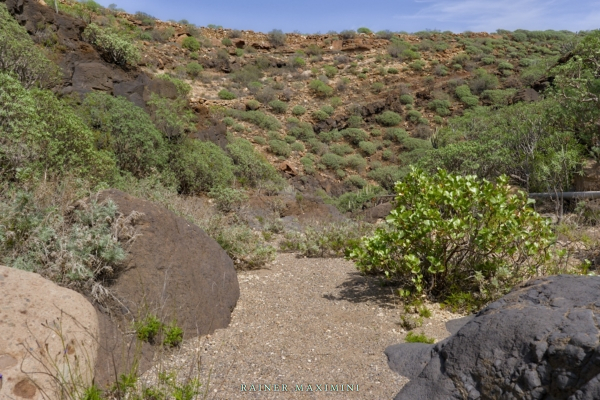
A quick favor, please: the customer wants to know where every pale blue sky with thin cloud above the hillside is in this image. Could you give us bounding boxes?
[96,0,600,33]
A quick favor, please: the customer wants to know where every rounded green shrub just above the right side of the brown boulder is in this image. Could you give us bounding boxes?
[171,139,234,194]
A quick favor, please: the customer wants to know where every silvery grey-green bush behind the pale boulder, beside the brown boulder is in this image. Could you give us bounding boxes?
[0,191,127,288]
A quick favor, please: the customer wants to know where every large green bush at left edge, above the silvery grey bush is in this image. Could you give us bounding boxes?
[0,72,115,181]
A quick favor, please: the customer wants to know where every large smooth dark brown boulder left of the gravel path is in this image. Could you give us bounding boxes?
[89,189,240,384]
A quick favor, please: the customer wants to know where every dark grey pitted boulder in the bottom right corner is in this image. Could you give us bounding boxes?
[388,275,600,400]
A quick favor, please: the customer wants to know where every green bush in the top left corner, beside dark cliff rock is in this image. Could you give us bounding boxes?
[0,4,60,88]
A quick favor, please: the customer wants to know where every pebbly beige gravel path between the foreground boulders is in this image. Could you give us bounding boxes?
[143,254,460,399]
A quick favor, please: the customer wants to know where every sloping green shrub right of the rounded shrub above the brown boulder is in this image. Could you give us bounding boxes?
[227,138,281,187]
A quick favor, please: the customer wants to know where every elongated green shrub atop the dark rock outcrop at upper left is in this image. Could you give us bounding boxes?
[82,23,141,66]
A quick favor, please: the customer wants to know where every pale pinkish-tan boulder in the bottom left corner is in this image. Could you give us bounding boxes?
[0,266,98,400]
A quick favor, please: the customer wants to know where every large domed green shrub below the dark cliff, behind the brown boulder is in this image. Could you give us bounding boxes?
[81,92,168,178]
